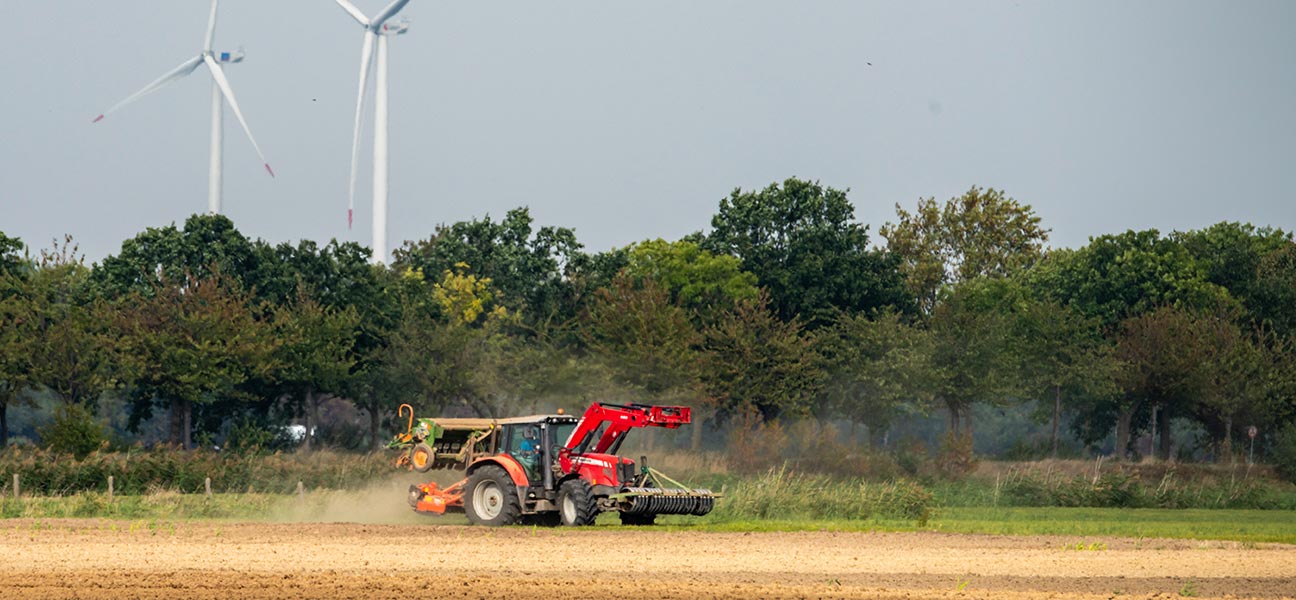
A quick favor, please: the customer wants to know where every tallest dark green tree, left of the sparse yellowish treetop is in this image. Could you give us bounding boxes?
[704,179,910,328]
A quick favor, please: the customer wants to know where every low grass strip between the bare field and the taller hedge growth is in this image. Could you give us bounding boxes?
[0,490,1296,544]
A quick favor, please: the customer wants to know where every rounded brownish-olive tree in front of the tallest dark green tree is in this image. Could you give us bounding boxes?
[702,293,824,420]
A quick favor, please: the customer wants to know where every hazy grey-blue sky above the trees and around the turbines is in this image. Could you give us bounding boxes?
[0,0,1296,260]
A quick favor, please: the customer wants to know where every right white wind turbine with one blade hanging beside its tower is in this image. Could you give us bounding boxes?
[337,0,410,264]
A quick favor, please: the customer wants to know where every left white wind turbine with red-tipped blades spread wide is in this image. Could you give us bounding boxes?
[93,0,275,214]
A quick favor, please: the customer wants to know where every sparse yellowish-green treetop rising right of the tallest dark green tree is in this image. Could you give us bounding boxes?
[881,185,1048,315]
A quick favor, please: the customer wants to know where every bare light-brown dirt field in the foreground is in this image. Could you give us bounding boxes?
[0,520,1296,600]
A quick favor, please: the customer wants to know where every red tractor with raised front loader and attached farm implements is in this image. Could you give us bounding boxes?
[389,403,719,526]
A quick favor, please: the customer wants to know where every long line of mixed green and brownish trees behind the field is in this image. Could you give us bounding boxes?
[0,179,1296,457]
